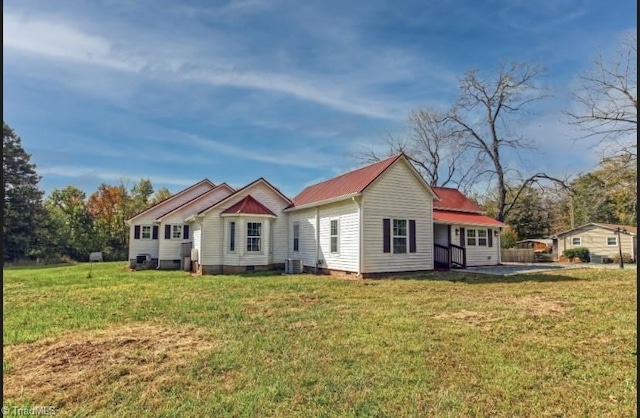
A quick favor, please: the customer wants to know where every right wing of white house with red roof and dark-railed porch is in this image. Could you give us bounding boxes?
[433,187,505,268]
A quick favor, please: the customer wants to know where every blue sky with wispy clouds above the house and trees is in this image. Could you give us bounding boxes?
[3,0,637,196]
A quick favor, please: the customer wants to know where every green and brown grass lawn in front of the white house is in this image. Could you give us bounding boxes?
[2,263,637,417]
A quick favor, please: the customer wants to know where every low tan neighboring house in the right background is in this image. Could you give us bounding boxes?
[552,223,638,260]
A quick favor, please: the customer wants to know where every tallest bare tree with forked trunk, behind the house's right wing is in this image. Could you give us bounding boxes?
[448,63,563,221]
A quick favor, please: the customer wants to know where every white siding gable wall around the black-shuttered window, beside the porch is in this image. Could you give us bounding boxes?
[363,160,433,273]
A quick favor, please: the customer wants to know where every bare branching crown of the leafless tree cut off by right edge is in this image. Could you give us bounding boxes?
[568,33,638,159]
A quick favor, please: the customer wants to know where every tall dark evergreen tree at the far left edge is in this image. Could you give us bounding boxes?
[2,121,44,261]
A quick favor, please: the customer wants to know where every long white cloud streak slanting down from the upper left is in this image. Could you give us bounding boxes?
[3,11,402,119]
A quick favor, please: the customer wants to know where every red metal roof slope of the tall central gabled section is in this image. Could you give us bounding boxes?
[292,154,402,206]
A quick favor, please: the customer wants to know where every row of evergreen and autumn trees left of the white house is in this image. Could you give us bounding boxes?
[2,121,171,262]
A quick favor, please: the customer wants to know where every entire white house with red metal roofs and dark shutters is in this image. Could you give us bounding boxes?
[127,154,504,277]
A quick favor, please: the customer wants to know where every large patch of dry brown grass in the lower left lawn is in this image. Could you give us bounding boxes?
[2,323,218,408]
